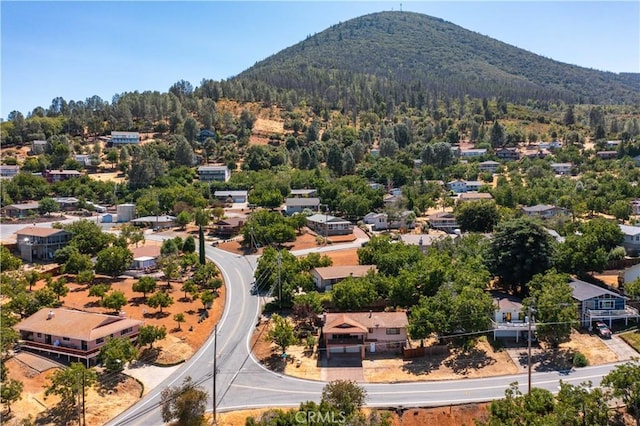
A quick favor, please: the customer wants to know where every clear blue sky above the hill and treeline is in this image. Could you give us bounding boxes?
[0,0,640,118]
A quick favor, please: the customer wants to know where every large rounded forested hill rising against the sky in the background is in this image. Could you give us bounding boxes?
[234,12,640,109]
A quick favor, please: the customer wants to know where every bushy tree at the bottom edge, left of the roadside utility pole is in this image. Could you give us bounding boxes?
[160,376,209,426]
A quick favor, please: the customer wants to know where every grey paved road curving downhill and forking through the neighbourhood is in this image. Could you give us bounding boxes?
[107,240,628,425]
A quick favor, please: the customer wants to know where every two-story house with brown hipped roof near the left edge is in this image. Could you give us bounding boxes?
[16,226,71,262]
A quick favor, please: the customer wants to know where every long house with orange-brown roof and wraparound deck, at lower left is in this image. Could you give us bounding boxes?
[14,308,142,367]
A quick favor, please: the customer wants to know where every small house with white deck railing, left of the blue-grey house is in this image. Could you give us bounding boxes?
[491,292,536,342]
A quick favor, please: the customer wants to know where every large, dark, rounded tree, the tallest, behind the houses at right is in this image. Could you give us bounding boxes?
[486,218,553,295]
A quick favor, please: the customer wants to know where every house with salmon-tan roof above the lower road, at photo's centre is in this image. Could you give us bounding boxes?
[322,311,409,359]
